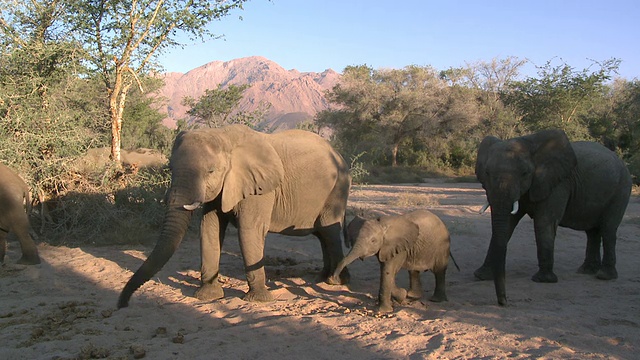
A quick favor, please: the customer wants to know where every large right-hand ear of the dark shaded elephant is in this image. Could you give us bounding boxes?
[522,130,578,202]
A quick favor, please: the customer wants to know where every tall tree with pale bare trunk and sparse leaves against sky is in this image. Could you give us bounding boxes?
[67,0,247,163]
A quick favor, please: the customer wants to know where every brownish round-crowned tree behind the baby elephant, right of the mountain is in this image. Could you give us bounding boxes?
[318,65,449,166]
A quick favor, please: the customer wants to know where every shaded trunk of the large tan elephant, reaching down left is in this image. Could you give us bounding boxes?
[118,208,192,309]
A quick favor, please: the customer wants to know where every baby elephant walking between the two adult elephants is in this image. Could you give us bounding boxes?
[328,210,450,313]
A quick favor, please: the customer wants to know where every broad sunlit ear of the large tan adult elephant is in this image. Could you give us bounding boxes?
[222,138,284,212]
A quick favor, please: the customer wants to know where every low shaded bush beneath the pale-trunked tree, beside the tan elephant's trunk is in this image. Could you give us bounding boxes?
[34,165,170,246]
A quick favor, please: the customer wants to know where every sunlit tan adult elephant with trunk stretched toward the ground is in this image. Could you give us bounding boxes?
[118,125,351,308]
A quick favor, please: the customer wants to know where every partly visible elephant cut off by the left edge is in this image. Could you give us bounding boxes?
[0,164,40,265]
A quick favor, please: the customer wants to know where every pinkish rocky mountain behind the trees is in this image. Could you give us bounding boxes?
[159,56,340,129]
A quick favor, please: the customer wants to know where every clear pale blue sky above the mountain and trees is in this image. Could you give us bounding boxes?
[160,0,640,80]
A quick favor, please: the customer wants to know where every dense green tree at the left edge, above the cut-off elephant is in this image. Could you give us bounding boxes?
[0,1,101,193]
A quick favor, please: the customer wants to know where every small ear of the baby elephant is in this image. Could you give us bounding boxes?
[378,216,420,262]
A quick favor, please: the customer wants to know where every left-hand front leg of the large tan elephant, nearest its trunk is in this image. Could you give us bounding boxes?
[194,207,228,301]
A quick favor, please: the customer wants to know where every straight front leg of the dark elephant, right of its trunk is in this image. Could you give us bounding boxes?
[531,220,558,283]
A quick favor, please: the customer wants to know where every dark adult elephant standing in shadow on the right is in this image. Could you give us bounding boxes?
[475,130,632,305]
